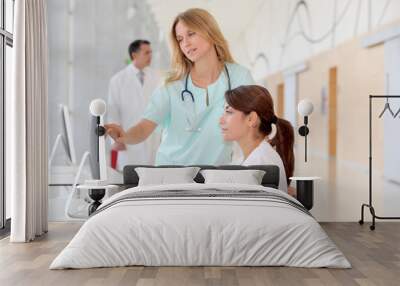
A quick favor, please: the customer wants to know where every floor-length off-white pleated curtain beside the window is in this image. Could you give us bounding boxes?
[6,0,48,242]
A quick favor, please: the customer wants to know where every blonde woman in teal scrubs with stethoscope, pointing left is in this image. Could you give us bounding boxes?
[106,9,254,165]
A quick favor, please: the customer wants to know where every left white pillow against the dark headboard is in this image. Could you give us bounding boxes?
[135,167,200,186]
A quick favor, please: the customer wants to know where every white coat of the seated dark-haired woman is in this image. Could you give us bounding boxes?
[234,140,288,193]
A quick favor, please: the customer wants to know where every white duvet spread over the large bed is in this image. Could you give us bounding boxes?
[50,184,351,269]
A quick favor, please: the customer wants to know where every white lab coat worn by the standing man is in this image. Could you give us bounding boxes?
[107,64,161,170]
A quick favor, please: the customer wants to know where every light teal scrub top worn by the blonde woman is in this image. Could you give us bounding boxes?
[143,63,254,165]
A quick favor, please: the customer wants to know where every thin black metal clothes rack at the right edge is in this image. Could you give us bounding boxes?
[358,95,400,230]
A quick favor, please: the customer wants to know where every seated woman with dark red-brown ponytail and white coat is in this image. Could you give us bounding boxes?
[220,85,294,192]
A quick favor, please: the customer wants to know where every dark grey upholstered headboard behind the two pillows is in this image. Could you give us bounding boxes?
[124,165,279,189]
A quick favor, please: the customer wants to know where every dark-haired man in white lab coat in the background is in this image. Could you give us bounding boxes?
[107,40,161,170]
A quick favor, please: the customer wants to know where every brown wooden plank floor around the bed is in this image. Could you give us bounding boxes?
[0,222,400,286]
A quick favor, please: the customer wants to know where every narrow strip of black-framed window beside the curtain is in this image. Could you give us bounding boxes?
[0,0,14,233]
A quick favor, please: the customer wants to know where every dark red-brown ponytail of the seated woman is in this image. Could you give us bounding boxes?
[270,118,294,184]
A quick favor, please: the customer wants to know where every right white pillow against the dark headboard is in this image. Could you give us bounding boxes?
[200,170,265,185]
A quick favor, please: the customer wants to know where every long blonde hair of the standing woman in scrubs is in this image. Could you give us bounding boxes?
[165,8,234,83]
